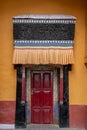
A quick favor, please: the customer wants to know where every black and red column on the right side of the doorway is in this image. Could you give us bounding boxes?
[59,65,69,127]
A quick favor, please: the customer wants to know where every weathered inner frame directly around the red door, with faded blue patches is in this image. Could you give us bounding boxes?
[26,65,59,124]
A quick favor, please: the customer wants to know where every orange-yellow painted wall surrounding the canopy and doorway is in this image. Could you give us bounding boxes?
[0,0,87,104]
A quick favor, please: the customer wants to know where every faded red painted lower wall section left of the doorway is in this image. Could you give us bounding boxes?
[0,101,16,124]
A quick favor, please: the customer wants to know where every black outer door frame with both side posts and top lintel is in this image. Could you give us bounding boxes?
[14,65,71,128]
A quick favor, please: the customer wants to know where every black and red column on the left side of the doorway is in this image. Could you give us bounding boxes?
[15,65,26,128]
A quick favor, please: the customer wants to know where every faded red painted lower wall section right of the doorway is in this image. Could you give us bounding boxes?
[69,105,86,128]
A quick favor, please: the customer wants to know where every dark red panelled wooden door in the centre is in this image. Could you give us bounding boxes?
[31,71,53,124]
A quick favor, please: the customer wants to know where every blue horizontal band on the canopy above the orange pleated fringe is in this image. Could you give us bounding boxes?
[14,42,74,47]
